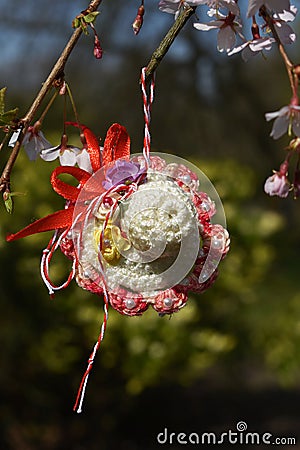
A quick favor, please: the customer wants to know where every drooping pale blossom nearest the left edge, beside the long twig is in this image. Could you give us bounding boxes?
[8,123,51,161]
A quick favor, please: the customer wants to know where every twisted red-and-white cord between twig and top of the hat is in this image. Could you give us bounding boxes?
[141,67,155,168]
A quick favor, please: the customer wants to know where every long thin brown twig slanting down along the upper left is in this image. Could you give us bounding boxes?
[0,0,102,192]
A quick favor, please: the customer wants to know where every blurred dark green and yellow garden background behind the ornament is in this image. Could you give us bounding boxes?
[0,0,300,450]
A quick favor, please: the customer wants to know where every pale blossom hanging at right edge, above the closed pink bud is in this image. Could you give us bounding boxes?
[265,103,300,139]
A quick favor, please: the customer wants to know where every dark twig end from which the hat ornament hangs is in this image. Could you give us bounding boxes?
[145,5,196,82]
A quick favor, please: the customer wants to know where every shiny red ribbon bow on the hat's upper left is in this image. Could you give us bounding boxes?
[6,122,130,242]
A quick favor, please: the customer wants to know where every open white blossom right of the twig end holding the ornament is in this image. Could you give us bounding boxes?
[194,10,243,52]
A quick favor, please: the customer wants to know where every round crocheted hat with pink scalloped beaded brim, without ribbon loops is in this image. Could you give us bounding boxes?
[70,149,229,316]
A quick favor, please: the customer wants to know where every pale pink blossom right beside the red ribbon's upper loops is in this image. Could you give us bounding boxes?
[40,134,92,173]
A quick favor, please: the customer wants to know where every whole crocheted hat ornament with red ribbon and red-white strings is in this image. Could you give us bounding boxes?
[7,67,229,412]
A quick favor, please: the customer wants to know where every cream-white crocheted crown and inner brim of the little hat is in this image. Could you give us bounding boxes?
[80,172,200,297]
